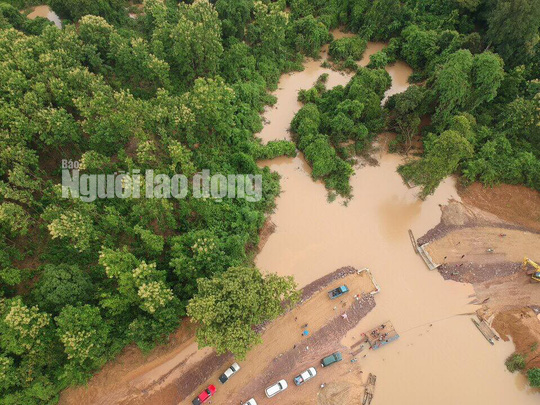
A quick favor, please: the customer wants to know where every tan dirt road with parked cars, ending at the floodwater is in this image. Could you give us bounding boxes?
[162,272,376,405]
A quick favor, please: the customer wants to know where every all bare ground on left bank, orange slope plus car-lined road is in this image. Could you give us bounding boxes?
[60,267,377,405]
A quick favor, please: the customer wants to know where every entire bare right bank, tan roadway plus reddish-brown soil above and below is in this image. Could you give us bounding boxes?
[418,184,540,368]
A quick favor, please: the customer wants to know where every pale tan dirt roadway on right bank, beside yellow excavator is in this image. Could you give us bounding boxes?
[418,198,540,311]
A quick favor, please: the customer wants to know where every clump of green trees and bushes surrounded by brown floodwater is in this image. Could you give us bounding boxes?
[291,68,391,197]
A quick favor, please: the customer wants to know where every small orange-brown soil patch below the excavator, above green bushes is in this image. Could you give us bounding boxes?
[493,307,540,369]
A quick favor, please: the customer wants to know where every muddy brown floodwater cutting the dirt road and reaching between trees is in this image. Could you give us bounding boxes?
[256,39,540,405]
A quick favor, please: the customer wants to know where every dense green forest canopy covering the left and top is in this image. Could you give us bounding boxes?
[0,0,540,404]
